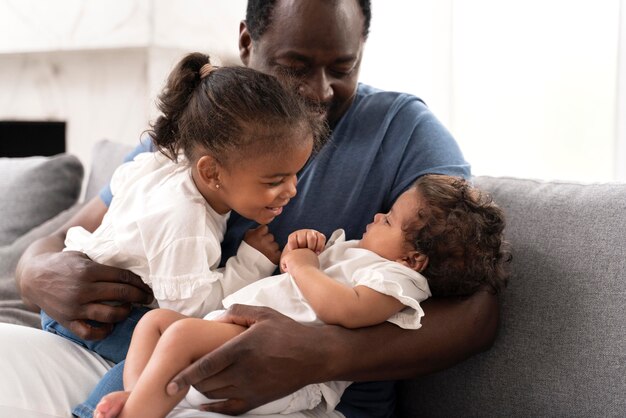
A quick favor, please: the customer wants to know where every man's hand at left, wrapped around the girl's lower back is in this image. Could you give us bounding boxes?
[21,251,153,340]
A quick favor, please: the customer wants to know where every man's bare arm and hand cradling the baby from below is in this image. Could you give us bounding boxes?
[167,291,498,414]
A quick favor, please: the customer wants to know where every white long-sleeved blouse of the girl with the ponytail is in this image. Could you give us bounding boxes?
[65,152,276,317]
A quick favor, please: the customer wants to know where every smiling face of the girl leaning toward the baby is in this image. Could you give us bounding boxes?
[219,139,313,225]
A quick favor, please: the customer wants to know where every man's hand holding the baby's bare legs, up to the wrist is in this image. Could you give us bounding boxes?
[168,305,332,415]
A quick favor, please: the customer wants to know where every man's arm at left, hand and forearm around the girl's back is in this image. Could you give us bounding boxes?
[15,197,152,339]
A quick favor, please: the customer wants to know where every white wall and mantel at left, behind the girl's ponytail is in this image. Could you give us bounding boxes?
[0,0,246,178]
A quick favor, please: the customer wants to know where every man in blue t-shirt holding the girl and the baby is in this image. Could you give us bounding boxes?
[6,0,498,417]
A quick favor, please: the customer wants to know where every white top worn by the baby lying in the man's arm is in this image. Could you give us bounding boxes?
[223,229,430,329]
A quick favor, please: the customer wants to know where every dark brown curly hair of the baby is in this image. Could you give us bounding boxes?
[405,174,512,296]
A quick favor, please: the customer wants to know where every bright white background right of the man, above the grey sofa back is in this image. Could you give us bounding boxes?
[362,0,626,181]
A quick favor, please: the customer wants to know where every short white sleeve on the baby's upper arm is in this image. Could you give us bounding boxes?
[354,262,430,329]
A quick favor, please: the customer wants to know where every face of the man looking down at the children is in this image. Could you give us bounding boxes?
[239,0,365,128]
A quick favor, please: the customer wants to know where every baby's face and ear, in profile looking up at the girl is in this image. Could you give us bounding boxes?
[359,187,421,262]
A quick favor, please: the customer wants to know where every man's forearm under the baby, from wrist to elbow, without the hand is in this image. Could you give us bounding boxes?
[316,291,498,381]
